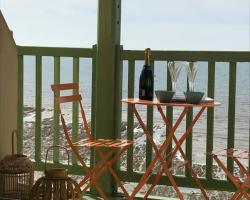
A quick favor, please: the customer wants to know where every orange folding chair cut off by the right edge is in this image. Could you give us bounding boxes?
[212,148,250,200]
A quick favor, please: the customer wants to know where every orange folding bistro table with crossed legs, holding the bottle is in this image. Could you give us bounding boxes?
[121,98,221,200]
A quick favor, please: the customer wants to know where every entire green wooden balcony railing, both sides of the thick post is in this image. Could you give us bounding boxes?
[18,46,250,195]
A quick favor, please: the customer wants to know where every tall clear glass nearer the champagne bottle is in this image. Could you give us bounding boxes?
[168,61,181,97]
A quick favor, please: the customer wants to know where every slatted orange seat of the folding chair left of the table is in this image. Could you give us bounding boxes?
[66,139,133,148]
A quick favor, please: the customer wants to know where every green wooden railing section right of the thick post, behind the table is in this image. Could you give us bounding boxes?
[120,50,250,191]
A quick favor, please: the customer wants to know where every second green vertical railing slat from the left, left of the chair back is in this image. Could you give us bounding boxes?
[35,56,42,161]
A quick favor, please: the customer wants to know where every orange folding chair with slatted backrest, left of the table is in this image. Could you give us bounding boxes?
[51,83,132,199]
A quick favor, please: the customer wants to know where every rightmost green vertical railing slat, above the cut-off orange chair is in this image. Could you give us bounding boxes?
[227,62,237,172]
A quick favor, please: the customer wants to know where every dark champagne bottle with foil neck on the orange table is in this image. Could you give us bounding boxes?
[139,48,154,100]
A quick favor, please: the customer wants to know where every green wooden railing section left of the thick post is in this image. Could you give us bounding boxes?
[18,46,95,174]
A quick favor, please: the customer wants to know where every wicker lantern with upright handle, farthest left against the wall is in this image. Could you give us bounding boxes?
[0,130,34,200]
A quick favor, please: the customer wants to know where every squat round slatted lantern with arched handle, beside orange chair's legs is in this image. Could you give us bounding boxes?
[30,146,83,200]
